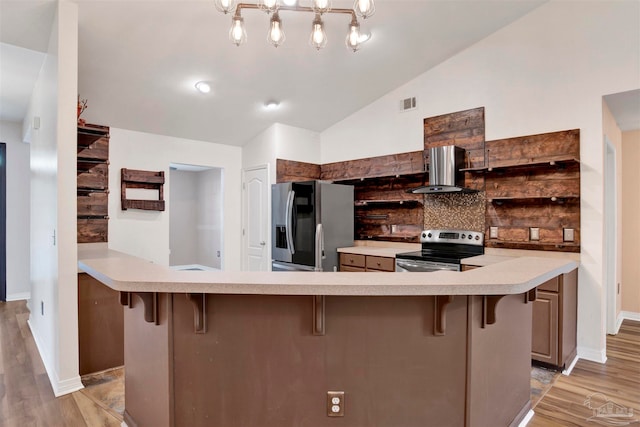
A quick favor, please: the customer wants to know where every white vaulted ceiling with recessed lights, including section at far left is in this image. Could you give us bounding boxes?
[0,0,636,145]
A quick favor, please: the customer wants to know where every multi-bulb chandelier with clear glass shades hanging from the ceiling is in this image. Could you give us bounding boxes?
[214,0,376,52]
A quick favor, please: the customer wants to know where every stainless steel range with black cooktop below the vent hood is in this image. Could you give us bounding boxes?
[396,230,484,272]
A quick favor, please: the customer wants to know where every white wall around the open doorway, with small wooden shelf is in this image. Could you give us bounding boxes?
[109,128,242,270]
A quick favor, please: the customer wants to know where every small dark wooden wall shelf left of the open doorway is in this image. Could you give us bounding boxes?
[120,168,164,211]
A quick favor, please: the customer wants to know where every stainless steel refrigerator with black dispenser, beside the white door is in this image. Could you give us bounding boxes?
[271,181,353,271]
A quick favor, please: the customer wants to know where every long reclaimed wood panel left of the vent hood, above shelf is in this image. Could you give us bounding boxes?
[321,151,425,181]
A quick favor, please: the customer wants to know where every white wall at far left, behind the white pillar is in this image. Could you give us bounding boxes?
[0,121,31,301]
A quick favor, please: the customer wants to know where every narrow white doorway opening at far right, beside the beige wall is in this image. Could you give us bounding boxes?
[604,136,618,335]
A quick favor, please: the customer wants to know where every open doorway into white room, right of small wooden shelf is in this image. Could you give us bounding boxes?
[169,163,224,271]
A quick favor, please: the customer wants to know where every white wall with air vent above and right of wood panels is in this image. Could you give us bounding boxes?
[321,1,640,361]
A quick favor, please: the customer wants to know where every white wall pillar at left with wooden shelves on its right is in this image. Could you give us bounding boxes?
[25,1,82,396]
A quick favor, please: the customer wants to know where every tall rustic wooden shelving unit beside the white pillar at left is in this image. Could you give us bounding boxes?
[76,124,109,243]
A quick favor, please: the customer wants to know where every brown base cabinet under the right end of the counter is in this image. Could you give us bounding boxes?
[531,270,578,369]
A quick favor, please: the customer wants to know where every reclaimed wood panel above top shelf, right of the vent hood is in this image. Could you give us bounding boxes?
[486,129,580,168]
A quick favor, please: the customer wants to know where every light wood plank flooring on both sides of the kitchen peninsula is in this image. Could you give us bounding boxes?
[0,301,640,427]
